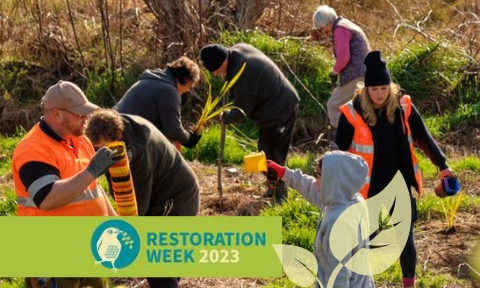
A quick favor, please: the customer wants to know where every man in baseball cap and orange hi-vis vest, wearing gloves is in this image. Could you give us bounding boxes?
[12,81,116,288]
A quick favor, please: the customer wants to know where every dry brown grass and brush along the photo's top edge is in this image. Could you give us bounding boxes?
[0,0,480,72]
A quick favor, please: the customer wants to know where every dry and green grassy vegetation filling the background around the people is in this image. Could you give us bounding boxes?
[0,0,480,288]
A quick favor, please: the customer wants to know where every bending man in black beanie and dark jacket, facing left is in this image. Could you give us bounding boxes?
[200,43,300,202]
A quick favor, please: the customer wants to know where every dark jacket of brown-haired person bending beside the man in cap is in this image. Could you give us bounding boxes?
[110,114,200,216]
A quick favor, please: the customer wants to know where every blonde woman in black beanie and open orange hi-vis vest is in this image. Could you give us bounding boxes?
[335,51,455,287]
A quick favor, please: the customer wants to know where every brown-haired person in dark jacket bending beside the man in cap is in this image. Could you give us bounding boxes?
[86,109,200,288]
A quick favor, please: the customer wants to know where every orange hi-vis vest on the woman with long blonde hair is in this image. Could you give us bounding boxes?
[340,95,422,199]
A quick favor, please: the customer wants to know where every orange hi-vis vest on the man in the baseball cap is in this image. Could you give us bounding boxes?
[12,124,108,216]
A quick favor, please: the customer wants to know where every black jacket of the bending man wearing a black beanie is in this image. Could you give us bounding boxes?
[224,43,300,128]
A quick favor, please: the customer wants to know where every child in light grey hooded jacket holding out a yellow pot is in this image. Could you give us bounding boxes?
[268,151,375,288]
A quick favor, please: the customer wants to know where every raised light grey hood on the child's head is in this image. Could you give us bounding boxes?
[321,151,368,207]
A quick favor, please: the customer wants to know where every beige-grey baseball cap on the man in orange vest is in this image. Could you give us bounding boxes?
[42,80,100,116]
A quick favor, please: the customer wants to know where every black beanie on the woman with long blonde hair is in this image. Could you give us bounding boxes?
[364,50,391,87]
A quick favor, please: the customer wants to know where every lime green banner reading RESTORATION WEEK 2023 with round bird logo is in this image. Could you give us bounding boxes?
[0,217,282,277]
